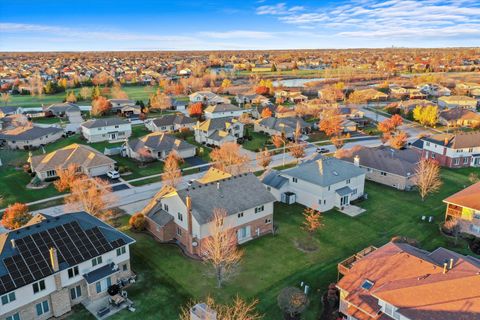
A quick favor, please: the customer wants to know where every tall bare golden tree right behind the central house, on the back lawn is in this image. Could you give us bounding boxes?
[202,208,243,288]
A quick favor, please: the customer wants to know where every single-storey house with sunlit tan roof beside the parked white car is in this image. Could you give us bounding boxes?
[28,143,116,181]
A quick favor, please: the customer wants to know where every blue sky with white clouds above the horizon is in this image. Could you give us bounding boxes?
[0,0,480,51]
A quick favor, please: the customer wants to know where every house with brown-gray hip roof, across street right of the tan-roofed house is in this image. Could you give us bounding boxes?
[125,132,196,162]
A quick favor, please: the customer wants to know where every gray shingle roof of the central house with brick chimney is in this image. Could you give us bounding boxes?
[177,173,275,224]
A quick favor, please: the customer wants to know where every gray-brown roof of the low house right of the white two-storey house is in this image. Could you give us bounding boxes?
[342,146,421,177]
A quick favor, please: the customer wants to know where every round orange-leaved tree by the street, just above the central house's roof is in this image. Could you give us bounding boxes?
[210,141,250,174]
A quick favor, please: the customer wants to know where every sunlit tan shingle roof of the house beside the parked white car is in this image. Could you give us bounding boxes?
[31,143,116,172]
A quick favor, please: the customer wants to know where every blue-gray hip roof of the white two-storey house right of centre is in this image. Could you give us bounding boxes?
[282,156,365,187]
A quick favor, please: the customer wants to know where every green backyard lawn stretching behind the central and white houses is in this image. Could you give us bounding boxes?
[68,169,474,320]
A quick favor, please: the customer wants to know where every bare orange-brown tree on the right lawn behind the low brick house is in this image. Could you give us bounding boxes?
[415,159,442,201]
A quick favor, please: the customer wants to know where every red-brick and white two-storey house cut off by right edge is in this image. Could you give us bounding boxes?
[422,131,480,168]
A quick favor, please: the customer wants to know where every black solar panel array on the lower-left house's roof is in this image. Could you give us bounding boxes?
[0,221,125,295]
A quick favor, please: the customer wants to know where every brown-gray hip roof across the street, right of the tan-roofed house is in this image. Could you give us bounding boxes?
[128,132,196,152]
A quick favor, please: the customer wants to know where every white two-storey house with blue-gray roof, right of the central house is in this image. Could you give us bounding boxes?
[262,156,365,212]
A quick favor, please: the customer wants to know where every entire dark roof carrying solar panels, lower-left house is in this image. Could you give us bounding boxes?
[0,212,135,295]
